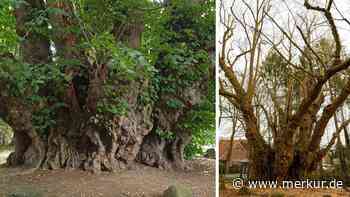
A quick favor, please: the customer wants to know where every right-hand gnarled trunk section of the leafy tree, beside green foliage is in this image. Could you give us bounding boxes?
[138,82,208,169]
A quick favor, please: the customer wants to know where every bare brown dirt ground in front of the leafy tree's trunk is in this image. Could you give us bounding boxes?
[0,159,215,197]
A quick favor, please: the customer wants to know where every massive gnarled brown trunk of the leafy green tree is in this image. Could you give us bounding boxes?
[0,0,211,172]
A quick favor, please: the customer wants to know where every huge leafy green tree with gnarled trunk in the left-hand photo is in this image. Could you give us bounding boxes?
[0,0,214,172]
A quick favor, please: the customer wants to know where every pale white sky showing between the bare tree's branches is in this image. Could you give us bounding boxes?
[217,0,350,144]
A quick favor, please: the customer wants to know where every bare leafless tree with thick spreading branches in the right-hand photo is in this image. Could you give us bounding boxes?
[219,0,350,180]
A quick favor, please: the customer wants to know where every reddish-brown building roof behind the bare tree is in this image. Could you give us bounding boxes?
[219,139,248,162]
